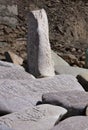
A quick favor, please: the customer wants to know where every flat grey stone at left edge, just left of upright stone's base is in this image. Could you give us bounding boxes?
[0,66,35,80]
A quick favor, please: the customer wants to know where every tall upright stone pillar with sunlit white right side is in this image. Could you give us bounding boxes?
[27,9,55,77]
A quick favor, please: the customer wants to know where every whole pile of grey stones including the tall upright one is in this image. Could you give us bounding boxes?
[0,9,88,130]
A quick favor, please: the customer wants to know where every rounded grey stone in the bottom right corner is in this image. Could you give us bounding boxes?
[51,116,88,130]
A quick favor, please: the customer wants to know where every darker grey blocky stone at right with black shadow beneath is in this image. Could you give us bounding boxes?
[42,91,88,116]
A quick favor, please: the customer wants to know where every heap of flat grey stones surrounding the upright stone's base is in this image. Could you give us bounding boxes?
[0,53,88,130]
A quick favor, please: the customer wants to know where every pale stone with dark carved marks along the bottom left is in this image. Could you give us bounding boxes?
[0,104,67,130]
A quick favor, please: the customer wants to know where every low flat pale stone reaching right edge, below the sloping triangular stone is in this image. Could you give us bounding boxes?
[55,66,88,77]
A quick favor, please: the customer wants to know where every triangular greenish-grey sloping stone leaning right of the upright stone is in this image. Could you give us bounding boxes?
[51,50,69,70]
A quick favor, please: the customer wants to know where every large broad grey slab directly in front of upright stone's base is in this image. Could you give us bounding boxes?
[0,75,84,113]
